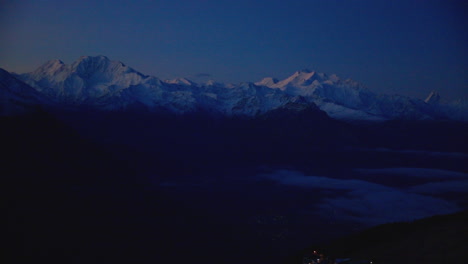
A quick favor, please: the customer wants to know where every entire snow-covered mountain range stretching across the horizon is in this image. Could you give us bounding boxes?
[0,56,468,121]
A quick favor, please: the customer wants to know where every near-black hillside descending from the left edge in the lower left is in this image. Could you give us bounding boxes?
[0,114,239,263]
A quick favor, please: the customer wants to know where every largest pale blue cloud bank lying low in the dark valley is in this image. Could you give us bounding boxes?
[261,169,462,225]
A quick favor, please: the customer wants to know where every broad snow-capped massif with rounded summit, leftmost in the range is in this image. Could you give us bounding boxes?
[18,56,156,104]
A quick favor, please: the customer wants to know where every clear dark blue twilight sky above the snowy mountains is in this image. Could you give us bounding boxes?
[0,0,468,99]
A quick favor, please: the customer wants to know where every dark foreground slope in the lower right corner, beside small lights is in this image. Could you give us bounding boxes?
[288,211,468,264]
